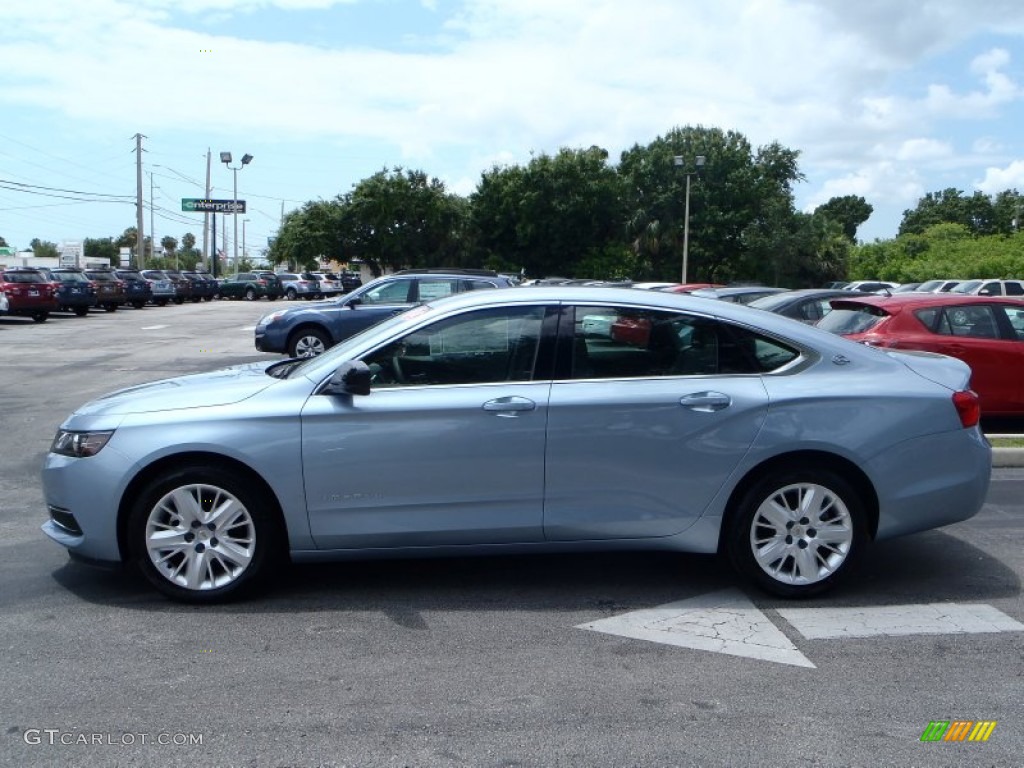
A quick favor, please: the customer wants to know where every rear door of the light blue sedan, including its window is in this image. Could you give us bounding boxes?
[544,306,770,541]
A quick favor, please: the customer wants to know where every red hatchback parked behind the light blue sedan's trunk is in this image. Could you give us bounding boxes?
[817,293,1024,416]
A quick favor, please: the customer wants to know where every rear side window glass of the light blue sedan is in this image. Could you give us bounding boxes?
[570,306,800,379]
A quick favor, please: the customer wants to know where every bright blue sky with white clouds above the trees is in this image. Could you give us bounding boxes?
[0,0,1024,262]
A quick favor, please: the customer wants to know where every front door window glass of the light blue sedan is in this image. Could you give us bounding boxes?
[364,307,545,387]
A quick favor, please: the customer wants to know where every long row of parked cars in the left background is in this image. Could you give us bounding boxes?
[0,267,361,323]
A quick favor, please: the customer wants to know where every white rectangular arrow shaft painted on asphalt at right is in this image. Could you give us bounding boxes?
[778,603,1024,640]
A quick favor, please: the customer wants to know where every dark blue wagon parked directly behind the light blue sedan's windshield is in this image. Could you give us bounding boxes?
[256,269,512,357]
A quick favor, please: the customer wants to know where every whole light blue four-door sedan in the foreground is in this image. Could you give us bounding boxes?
[43,287,991,602]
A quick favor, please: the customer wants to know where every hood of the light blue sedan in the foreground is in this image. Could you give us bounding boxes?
[69,361,275,416]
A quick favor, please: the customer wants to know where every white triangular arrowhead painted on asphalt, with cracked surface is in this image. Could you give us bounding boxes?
[577,590,814,669]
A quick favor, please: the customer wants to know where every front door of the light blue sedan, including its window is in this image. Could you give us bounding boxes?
[302,306,553,549]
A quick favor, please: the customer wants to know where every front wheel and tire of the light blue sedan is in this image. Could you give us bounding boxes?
[127,464,287,603]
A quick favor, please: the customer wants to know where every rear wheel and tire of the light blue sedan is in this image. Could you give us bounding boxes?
[727,466,867,598]
